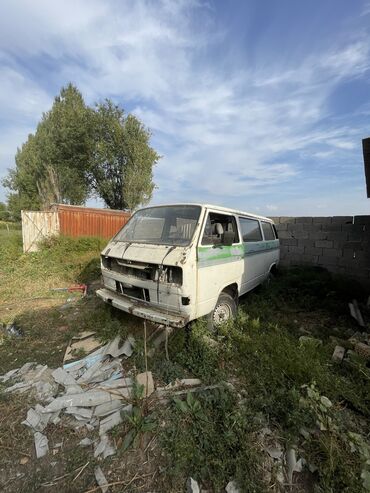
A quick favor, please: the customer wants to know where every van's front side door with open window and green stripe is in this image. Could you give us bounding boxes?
[197,211,244,317]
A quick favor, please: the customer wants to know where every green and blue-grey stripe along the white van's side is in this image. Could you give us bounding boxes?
[198,240,279,267]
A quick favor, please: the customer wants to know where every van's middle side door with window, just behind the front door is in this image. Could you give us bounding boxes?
[239,216,266,294]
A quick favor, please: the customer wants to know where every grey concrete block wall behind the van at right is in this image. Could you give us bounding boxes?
[271,216,370,285]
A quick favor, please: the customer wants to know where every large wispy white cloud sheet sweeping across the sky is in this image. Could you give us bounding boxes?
[0,0,370,212]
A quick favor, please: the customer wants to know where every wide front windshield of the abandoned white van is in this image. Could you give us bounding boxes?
[114,205,201,246]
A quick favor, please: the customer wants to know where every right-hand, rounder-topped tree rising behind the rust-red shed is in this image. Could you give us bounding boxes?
[89,99,160,210]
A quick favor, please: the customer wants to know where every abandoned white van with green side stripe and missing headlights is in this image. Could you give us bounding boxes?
[97,204,279,327]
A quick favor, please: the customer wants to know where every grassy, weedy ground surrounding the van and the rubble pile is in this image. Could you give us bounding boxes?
[0,232,370,493]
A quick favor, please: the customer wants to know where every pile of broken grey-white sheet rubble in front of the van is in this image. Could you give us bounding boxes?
[0,336,135,460]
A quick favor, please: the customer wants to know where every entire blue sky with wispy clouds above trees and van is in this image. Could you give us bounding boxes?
[0,0,370,216]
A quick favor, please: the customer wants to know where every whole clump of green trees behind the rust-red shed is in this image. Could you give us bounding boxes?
[3,84,159,218]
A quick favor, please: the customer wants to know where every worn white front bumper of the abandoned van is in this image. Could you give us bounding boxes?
[96,288,189,327]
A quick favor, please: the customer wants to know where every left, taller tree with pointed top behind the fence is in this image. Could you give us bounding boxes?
[4,84,93,217]
